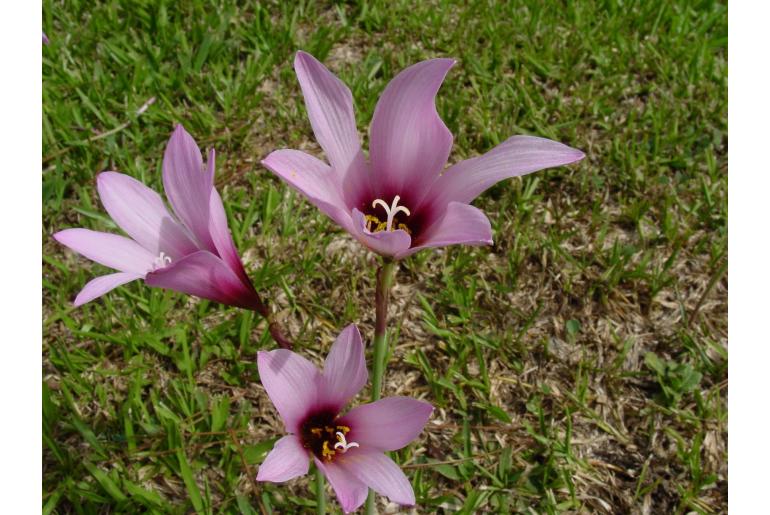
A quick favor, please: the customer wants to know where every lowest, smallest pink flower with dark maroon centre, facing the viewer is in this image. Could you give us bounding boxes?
[257,325,433,513]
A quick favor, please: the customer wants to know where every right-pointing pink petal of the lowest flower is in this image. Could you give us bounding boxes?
[341,397,433,451]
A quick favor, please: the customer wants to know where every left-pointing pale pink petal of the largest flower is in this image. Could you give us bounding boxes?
[262,149,352,231]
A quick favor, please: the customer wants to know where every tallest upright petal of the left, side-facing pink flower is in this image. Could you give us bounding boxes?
[163,125,215,252]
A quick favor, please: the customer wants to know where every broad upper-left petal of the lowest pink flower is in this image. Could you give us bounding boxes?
[257,349,321,433]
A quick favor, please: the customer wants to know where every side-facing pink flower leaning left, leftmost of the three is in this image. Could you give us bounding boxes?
[54,125,266,311]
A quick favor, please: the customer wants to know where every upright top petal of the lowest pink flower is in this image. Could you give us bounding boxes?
[321,324,369,411]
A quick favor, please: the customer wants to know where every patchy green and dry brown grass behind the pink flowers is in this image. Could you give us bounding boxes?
[42,0,727,513]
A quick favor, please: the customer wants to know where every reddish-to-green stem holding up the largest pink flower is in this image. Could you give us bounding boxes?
[366,260,396,515]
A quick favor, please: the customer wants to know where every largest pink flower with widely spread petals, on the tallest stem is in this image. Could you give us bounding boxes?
[262,52,584,259]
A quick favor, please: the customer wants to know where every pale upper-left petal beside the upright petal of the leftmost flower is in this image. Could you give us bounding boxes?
[96,172,198,259]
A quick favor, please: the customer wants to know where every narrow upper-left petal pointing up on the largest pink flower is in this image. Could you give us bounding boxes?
[294,52,361,177]
